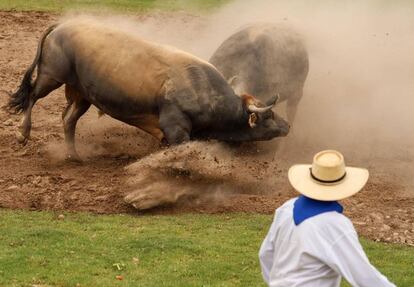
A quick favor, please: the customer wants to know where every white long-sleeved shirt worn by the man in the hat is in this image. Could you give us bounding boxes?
[259,198,395,287]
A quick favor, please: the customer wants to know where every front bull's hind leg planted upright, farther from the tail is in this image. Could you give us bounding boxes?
[62,85,91,161]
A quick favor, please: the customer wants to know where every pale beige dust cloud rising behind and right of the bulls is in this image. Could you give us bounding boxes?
[137,0,414,160]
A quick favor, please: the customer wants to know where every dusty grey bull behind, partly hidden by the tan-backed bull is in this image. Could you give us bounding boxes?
[210,23,309,124]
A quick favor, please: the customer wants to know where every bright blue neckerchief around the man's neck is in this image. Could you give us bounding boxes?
[293,195,344,225]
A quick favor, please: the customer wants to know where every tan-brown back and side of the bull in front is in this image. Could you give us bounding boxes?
[48,19,212,122]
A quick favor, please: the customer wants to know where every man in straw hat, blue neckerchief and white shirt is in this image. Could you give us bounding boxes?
[259,150,395,287]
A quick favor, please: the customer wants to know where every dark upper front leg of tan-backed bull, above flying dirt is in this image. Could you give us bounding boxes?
[160,104,192,145]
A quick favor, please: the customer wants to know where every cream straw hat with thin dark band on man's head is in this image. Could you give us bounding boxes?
[288,150,369,201]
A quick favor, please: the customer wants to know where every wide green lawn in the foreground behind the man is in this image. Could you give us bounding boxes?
[0,210,414,287]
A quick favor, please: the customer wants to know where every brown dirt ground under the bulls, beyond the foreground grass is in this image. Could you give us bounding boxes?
[0,11,414,245]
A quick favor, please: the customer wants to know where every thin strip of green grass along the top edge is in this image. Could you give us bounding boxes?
[0,0,230,12]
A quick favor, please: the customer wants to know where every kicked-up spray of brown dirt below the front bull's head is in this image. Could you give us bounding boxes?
[125,142,276,209]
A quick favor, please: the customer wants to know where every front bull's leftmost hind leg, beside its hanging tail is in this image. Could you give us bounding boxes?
[17,74,62,144]
